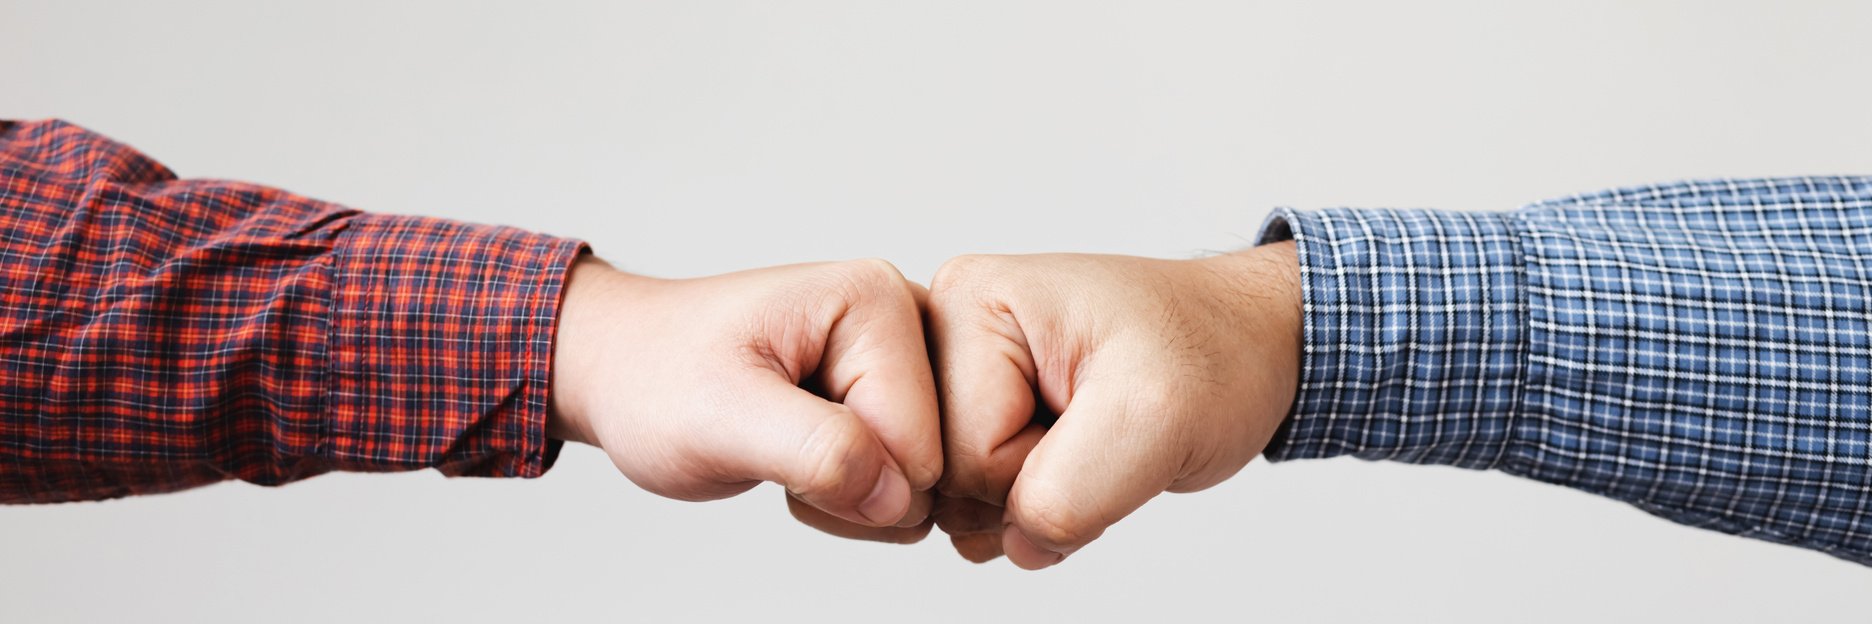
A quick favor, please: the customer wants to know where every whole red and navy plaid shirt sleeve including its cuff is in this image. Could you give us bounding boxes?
[0,122,584,502]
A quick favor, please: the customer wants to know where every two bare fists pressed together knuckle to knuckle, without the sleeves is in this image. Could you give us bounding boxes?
[548,242,1301,570]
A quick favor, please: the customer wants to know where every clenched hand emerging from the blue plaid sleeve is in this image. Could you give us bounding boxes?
[929,242,1301,570]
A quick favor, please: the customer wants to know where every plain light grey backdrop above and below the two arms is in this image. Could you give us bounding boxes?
[0,0,1872,622]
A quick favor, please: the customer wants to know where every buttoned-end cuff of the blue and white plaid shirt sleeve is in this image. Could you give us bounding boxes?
[1260,208,1528,468]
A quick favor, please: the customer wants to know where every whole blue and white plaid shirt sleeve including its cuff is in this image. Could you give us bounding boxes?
[1262,176,1872,564]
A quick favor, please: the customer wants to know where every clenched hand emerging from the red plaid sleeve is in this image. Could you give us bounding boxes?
[547,259,942,542]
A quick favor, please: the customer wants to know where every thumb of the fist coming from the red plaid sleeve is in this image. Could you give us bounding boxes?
[717,379,910,527]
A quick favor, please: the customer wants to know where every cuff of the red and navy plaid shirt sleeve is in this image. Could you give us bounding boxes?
[320,214,586,476]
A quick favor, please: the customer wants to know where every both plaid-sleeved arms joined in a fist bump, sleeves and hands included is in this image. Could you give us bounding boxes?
[0,120,1872,568]
